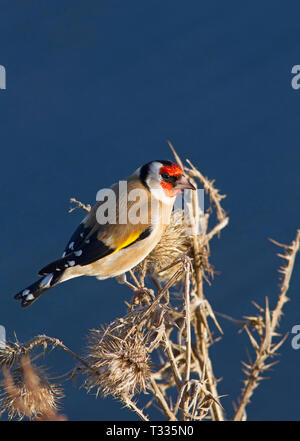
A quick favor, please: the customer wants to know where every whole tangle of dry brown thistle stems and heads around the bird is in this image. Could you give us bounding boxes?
[0,143,300,421]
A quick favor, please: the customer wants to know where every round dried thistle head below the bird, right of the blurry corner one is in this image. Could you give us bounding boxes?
[86,321,150,400]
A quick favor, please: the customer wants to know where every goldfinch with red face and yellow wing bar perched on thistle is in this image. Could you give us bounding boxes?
[15,160,194,307]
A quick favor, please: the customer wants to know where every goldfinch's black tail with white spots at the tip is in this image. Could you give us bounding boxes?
[15,272,63,308]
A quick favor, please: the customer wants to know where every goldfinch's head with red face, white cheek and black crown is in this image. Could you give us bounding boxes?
[137,160,195,203]
